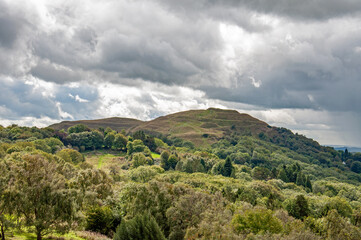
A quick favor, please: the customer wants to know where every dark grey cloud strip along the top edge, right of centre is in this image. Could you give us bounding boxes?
[160,0,361,23]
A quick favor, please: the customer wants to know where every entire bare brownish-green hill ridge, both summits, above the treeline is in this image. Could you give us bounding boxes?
[49,108,275,146]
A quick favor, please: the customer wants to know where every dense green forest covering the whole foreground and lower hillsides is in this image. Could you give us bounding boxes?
[0,110,361,240]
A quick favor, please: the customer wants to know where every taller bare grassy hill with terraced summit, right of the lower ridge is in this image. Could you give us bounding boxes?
[130,108,273,146]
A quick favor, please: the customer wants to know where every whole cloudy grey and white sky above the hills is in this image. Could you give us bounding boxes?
[0,0,361,147]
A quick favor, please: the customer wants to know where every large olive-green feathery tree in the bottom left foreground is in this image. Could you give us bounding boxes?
[13,155,75,240]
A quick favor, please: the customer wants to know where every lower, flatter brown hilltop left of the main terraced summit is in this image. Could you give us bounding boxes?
[49,117,143,131]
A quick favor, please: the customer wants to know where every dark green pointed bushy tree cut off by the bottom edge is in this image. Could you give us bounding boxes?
[114,213,166,240]
